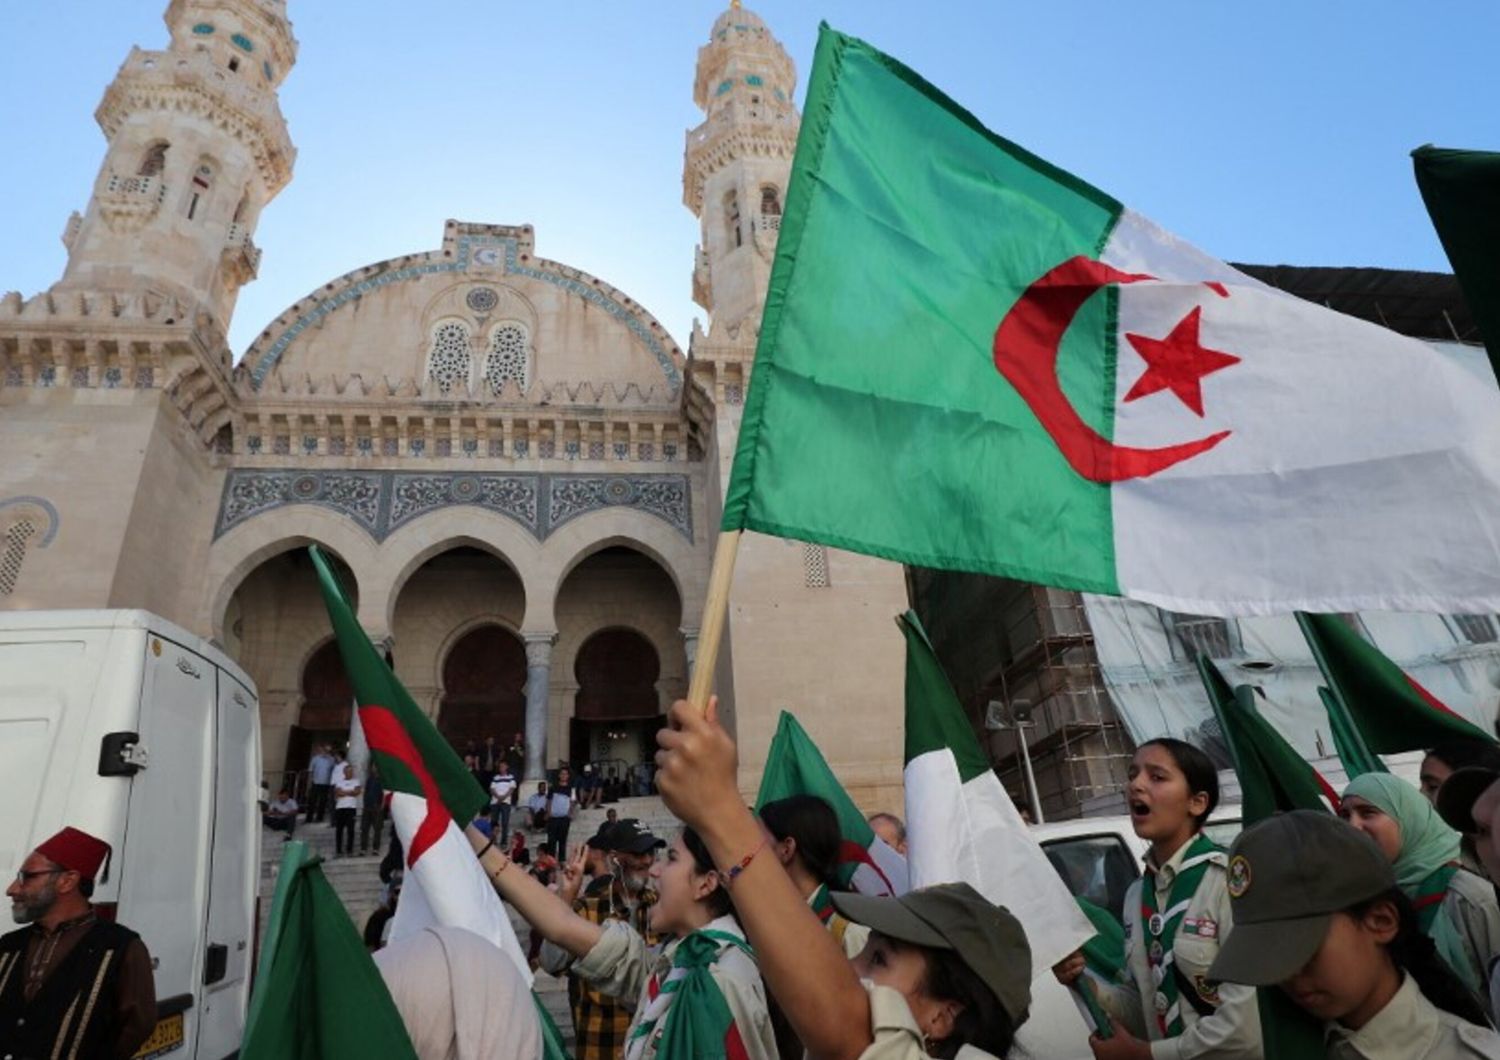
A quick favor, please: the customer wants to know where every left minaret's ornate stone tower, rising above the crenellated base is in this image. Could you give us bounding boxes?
[53,0,297,331]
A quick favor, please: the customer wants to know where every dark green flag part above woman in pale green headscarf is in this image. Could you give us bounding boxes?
[1298,612,1493,754]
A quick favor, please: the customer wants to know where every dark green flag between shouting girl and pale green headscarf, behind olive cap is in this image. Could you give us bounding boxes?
[1197,654,1337,1060]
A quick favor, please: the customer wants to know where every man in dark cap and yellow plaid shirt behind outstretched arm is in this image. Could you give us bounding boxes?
[542,817,666,1060]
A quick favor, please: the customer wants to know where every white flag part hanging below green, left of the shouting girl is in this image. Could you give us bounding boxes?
[906,748,1094,1060]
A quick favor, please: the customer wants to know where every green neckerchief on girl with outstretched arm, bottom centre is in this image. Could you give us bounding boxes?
[626,928,755,1060]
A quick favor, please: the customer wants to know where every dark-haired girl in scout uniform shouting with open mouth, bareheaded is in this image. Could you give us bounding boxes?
[1055,739,1262,1060]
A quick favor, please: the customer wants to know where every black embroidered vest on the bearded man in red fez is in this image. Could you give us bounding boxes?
[0,921,138,1060]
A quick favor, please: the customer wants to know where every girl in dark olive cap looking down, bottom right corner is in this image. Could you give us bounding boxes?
[1209,810,1500,1060]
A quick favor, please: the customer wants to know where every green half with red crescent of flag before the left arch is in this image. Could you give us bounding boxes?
[308,544,489,845]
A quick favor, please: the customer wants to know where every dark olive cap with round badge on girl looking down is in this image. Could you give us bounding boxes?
[1208,810,1397,987]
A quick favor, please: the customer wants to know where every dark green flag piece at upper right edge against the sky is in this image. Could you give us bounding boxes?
[1412,144,1500,375]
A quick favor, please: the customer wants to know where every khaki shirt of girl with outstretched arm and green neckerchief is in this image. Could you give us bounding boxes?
[573,916,779,1060]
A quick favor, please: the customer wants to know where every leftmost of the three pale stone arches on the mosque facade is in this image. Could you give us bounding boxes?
[200,505,375,643]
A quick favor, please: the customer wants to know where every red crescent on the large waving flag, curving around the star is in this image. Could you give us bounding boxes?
[995,255,1230,483]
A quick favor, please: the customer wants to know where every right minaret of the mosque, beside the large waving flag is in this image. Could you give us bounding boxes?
[683,0,798,345]
